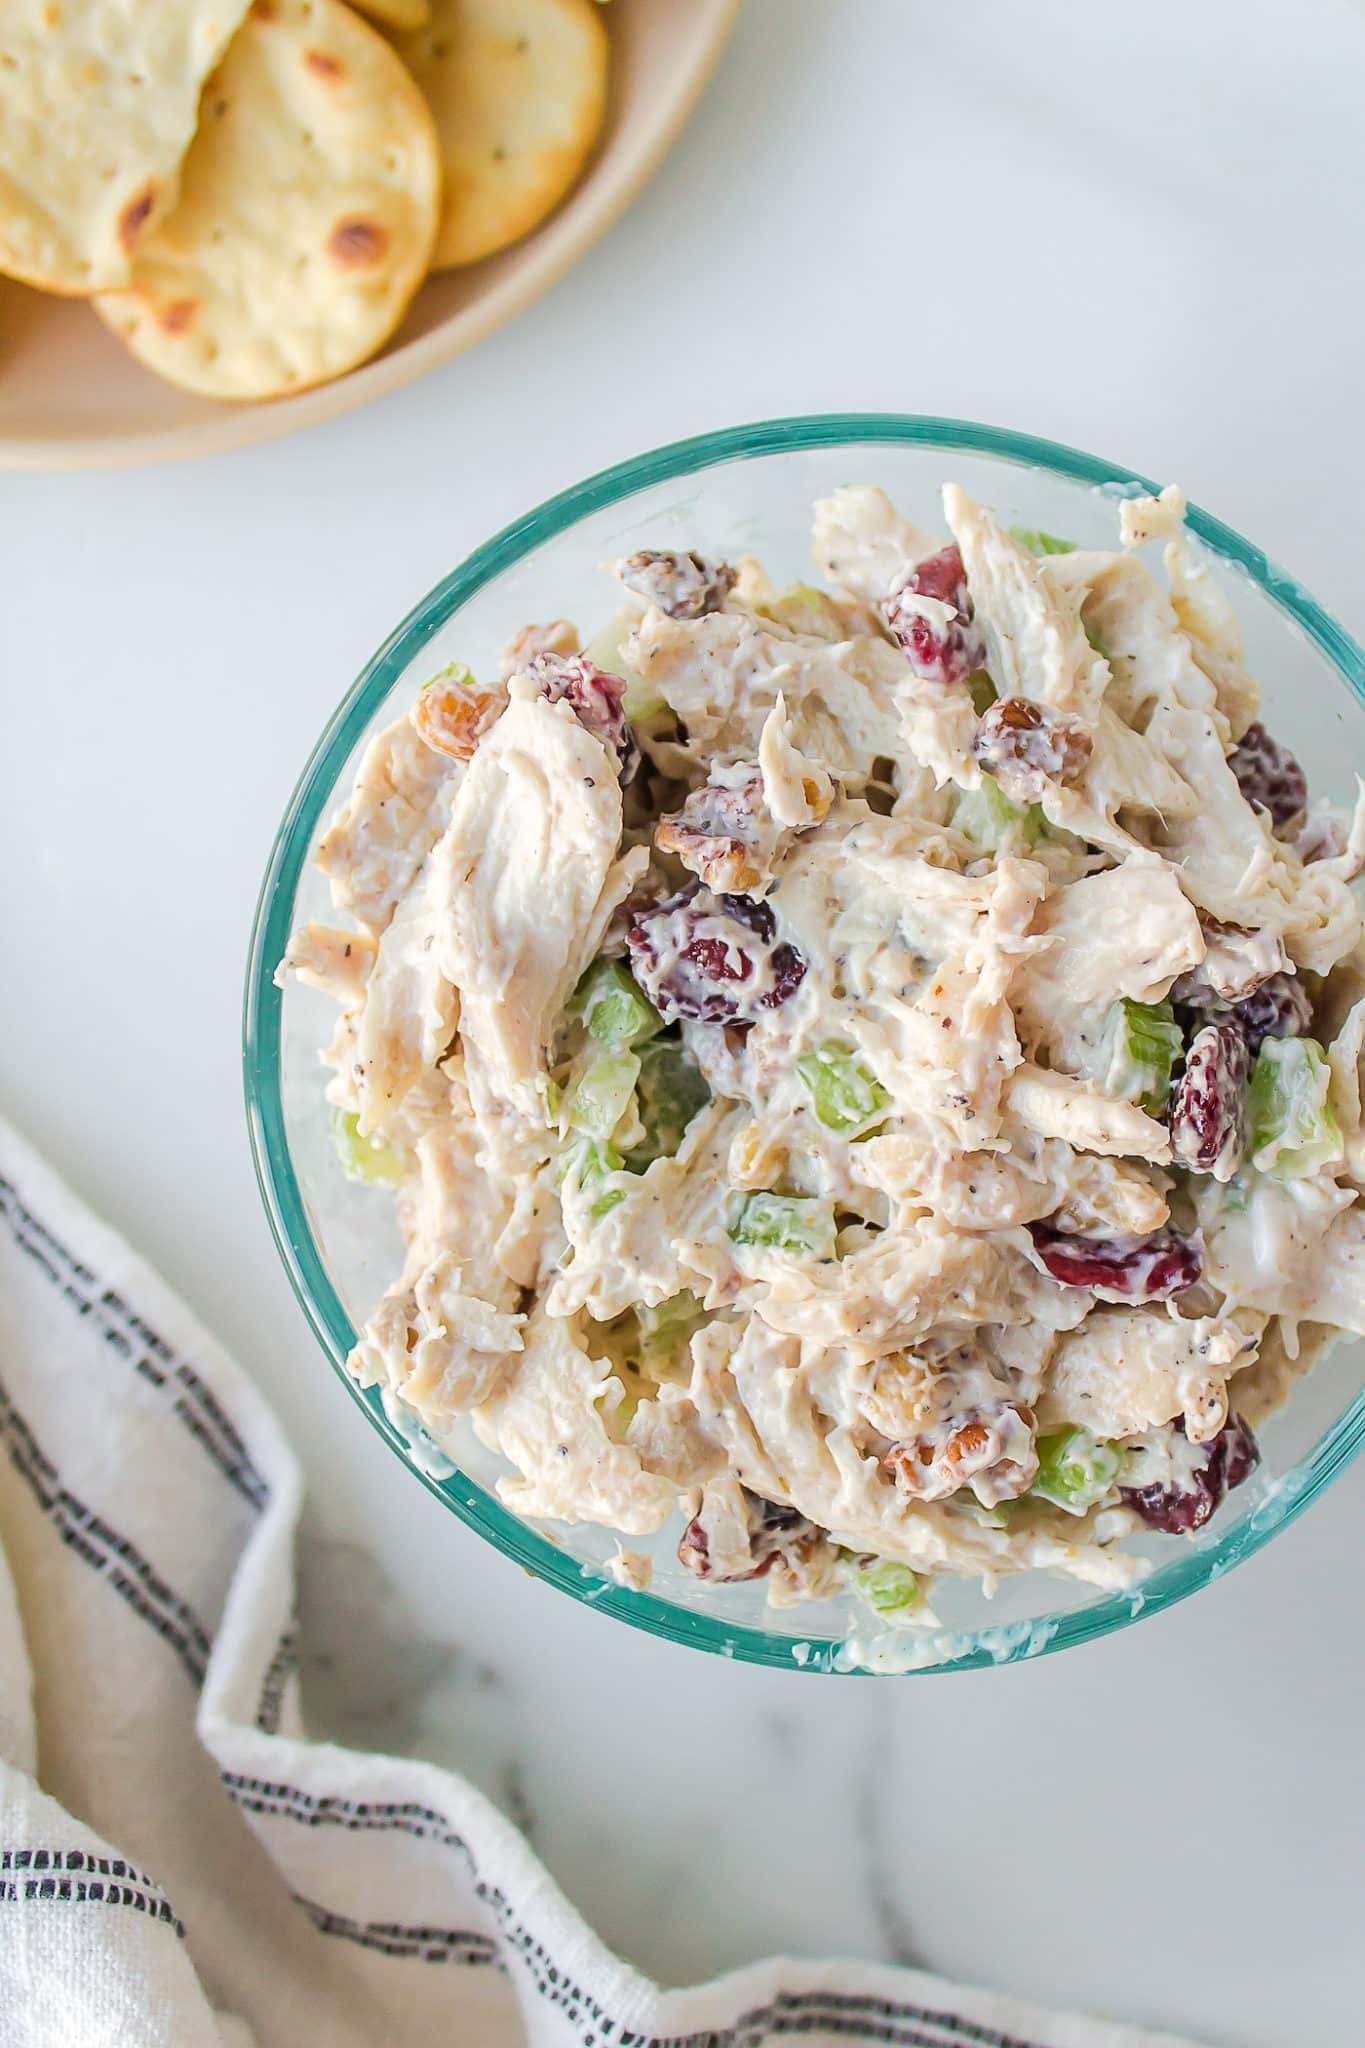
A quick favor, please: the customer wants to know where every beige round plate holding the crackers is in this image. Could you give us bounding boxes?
[0,0,739,469]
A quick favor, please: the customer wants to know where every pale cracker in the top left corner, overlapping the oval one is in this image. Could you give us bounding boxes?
[0,0,248,295]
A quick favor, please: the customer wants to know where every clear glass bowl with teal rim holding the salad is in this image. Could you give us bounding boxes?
[244,414,1365,1671]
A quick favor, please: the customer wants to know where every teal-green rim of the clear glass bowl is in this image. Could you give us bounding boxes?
[241,412,1365,1675]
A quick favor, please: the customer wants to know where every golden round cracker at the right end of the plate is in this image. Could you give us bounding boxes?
[395,0,608,270]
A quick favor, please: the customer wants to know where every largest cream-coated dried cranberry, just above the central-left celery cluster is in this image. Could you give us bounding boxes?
[626,883,806,1024]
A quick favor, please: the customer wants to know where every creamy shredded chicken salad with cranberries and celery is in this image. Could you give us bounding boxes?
[282,485,1365,1630]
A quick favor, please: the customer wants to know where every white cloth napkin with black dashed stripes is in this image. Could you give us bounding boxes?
[0,1124,1189,2048]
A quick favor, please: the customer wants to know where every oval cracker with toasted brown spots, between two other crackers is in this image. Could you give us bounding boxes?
[94,0,440,399]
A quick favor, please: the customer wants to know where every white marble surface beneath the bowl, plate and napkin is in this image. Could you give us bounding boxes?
[0,0,1365,2048]
